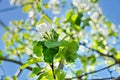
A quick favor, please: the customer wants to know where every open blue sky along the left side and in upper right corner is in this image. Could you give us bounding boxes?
[0,0,120,80]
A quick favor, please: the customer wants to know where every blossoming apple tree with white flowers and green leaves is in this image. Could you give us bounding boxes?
[0,0,120,80]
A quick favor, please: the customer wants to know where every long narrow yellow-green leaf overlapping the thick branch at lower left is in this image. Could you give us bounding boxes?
[20,58,42,69]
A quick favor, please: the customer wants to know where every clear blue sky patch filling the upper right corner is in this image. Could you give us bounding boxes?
[99,0,120,25]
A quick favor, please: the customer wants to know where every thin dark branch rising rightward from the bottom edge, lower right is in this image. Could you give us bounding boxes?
[66,62,118,80]
